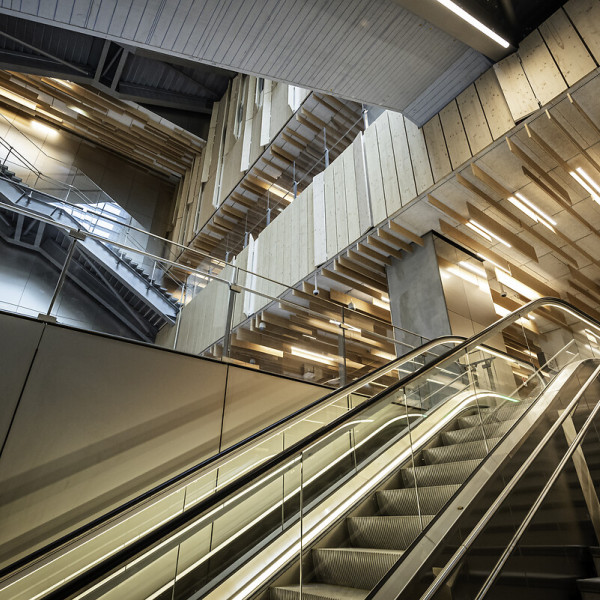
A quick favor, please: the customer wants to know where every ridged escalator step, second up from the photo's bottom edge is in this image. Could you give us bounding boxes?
[312,548,403,590]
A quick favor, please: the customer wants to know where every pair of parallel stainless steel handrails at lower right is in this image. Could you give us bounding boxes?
[420,366,600,600]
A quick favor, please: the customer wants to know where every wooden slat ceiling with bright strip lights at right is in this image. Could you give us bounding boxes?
[392,74,600,328]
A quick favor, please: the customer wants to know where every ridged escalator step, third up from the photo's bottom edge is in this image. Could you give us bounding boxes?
[346,515,435,550]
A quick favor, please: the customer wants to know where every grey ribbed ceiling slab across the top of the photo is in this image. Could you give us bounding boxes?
[0,0,490,120]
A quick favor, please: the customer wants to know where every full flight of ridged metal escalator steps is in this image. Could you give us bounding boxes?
[270,402,529,600]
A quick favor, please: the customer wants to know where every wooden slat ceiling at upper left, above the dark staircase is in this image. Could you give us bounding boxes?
[0,71,205,179]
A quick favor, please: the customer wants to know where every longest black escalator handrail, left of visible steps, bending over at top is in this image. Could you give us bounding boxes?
[7,297,600,600]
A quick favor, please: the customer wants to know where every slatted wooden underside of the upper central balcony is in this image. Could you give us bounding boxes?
[171,93,363,278]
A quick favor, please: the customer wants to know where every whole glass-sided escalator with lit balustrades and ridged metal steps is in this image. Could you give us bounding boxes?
[0,299,600,600]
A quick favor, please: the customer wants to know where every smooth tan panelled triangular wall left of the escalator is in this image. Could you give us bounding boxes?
[0,313,328,564]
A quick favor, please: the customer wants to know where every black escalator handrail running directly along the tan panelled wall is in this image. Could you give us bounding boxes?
[0,335,466,580]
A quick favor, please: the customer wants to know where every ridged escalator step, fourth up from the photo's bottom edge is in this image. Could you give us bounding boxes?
[376,484,460,516]
